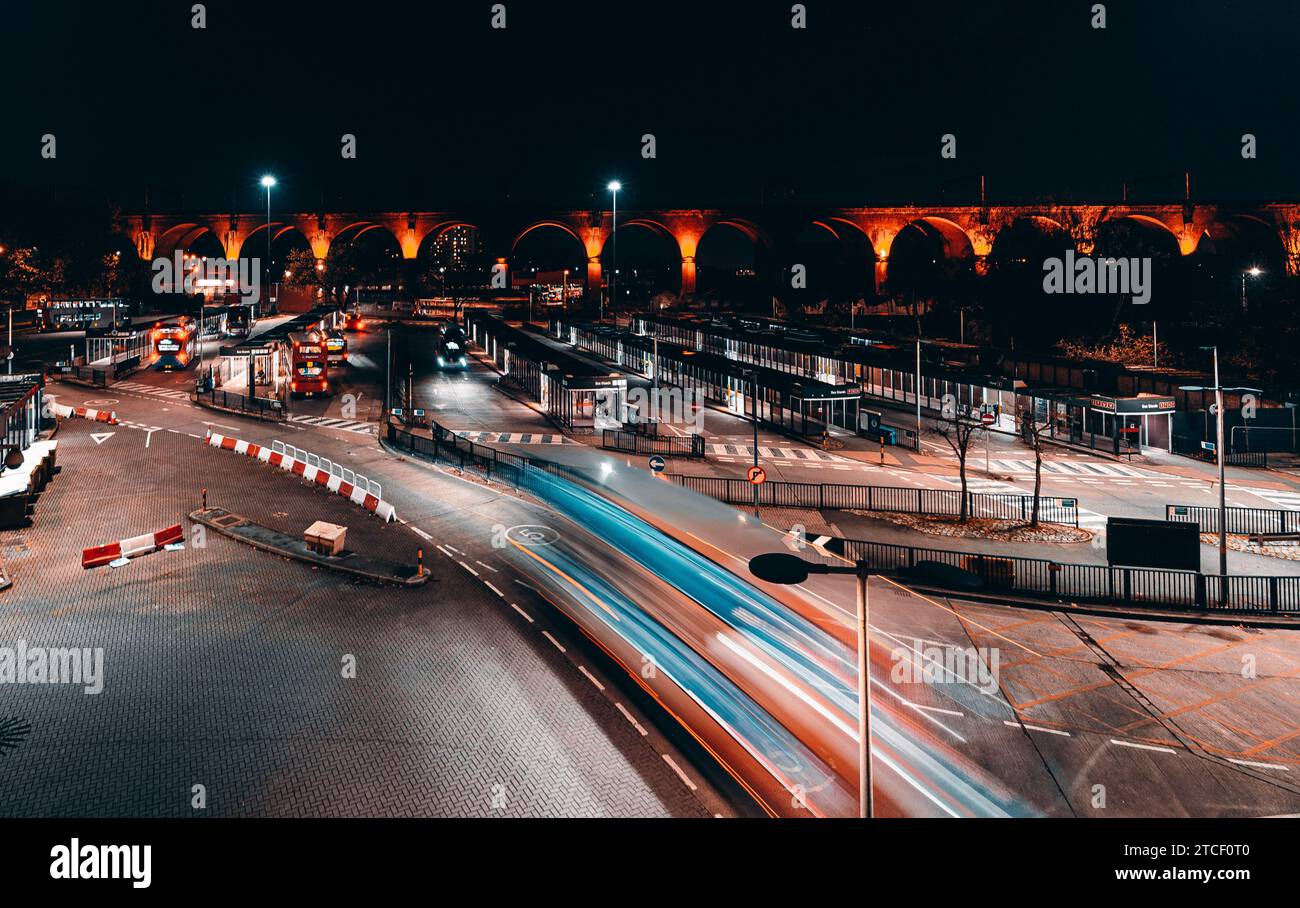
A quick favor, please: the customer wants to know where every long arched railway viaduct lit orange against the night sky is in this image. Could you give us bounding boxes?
[117,202,1300,294]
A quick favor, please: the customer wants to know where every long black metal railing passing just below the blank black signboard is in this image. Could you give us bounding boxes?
[803,540,1300,614]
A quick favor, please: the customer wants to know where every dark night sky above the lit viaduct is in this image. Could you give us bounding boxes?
[0,0,1300,209]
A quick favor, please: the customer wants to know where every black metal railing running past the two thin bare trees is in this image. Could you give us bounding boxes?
[670,474,1079,527]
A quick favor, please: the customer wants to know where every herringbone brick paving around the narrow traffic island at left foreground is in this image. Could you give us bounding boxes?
[0,423,706,817]
